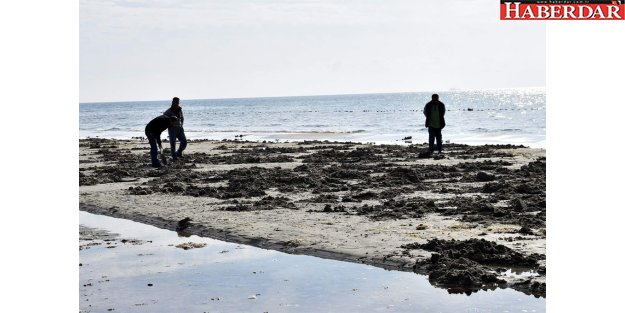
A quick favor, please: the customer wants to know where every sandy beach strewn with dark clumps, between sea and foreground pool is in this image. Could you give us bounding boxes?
[79,138,546,297]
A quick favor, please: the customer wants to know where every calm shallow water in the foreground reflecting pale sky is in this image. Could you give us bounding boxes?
[79,212,545,312]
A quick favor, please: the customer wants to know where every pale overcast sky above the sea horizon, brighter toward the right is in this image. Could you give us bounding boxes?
[79,0,546,102]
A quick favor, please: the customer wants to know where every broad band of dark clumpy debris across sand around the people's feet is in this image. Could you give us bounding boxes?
[79,139,546,229]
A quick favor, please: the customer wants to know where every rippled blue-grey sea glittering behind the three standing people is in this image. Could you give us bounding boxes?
[79,88,546,148]
